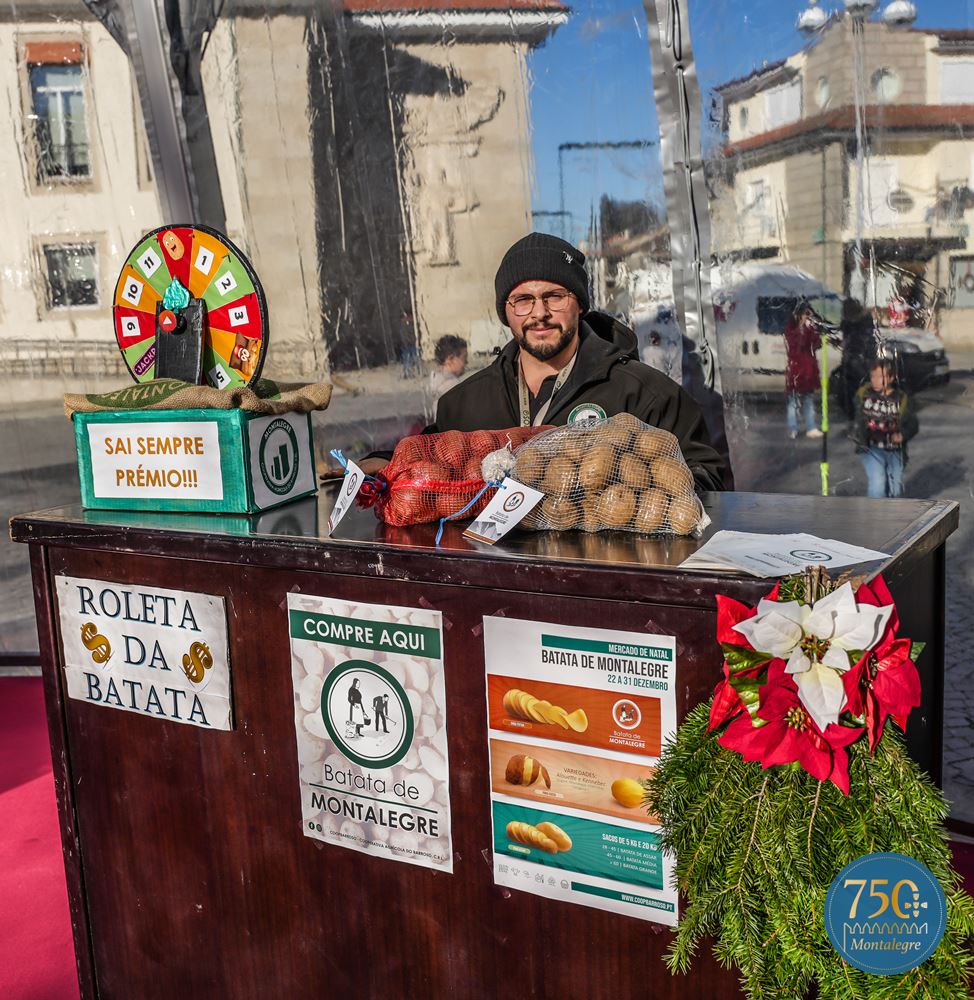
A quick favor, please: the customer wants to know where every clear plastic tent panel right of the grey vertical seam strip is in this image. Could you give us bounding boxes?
[689,0,974,821]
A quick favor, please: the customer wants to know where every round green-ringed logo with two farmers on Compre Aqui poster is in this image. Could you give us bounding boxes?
[321,660,414,770]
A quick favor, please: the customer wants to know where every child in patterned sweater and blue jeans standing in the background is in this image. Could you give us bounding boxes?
[850,358,920,497]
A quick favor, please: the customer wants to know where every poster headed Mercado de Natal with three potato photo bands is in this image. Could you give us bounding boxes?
[484,617,678,926]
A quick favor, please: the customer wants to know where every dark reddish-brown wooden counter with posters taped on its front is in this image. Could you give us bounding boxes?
[11,491,958,1000]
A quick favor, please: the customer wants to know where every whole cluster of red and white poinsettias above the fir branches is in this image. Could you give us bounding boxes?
[710,577,922,794]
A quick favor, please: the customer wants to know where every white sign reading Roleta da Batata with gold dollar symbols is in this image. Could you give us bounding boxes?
[56,576,233,729]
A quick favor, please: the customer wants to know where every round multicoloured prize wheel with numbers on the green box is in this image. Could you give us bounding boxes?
[112,225,268,389]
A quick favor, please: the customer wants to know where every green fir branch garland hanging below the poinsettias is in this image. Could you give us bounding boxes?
[647,703,974,1000]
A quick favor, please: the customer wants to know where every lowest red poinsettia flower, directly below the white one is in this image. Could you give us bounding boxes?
[718,666,865,795]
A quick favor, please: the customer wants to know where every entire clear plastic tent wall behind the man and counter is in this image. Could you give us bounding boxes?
[0,0,974,813]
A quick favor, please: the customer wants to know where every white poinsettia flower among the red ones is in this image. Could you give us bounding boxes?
[734,583,893,730]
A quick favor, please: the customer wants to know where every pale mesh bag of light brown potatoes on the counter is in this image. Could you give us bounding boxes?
[511,413,709,536]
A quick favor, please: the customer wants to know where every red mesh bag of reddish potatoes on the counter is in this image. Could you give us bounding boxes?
[359,427,549,527]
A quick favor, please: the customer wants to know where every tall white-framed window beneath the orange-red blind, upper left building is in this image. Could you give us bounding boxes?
[28,63,91,183]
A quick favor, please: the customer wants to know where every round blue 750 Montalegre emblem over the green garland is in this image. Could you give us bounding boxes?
[825,852,947,976]
